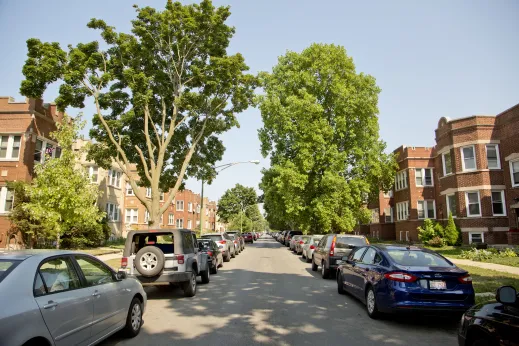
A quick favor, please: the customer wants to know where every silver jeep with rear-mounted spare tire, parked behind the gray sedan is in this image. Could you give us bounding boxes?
[119,229,210,297]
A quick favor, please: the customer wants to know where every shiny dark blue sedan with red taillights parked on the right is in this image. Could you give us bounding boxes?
[337,245,474,318]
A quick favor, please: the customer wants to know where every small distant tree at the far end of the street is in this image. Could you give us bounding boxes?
[217,184,259,222]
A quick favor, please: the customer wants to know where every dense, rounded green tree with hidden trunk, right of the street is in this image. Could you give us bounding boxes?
[258,44,395,232]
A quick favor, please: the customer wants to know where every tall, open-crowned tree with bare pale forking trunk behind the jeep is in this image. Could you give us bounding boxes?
[21,0,256,227]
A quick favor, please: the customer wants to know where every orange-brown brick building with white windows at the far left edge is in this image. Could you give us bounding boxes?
[0,97,63,248]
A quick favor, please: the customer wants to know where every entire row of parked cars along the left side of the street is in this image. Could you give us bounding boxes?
[0,229,260,346]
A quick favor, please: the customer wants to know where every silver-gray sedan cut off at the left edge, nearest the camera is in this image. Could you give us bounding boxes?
[0,251,147,346]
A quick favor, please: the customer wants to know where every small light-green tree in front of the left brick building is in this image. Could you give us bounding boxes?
[11,116,106,248]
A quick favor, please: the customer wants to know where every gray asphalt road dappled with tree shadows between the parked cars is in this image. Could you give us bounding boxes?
[103,237,459,346]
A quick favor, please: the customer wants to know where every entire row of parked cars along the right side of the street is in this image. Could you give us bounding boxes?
[272,231,519,346]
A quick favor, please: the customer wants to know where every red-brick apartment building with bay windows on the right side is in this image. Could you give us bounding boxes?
[360,105,519,244]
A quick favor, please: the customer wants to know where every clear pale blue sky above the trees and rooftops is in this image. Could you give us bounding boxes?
[0,0,519,203]
